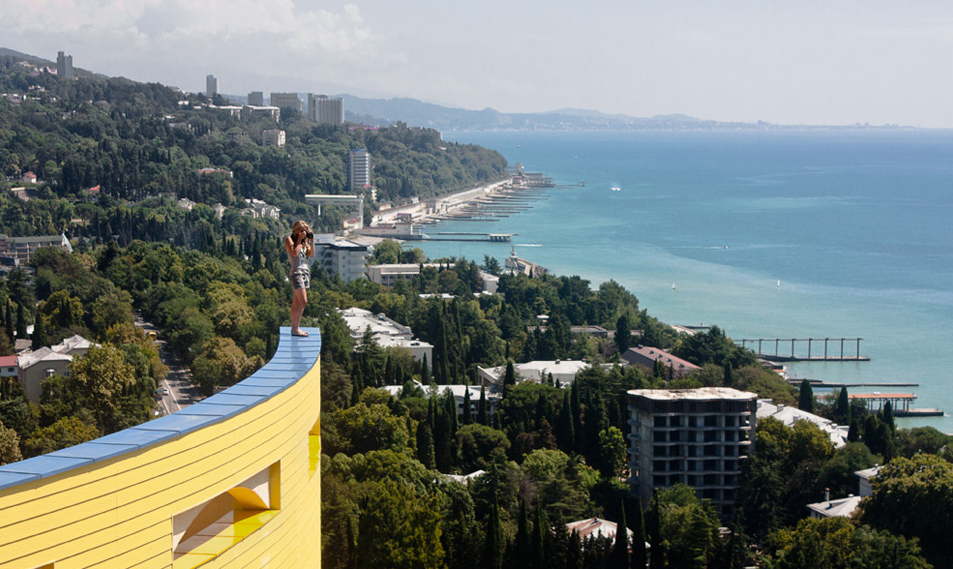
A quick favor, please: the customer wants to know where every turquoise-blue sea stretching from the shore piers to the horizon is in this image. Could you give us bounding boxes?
[412,129,953,433]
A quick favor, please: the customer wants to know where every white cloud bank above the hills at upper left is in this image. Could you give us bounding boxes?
[0,0,394,83]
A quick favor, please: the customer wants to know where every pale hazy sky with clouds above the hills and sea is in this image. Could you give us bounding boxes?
[0,0,953,127]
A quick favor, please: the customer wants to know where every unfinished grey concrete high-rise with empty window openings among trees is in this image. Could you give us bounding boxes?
[628,387,758,511]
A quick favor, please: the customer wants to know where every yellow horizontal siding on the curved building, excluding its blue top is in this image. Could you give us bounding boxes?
[0,329,321,569]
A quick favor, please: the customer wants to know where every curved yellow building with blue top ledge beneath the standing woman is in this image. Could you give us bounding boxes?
[0,328,321,569]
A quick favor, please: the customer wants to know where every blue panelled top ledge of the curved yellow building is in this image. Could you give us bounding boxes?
[0,326,321,491]
